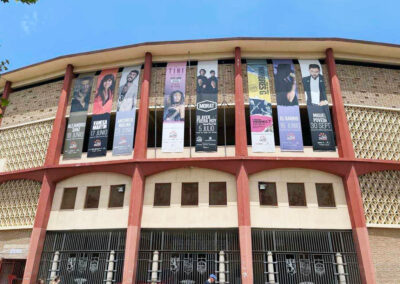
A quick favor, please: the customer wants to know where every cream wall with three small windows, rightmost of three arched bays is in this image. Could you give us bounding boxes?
[249,168,351,229]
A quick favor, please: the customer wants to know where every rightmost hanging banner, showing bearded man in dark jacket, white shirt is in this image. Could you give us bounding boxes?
[299,60,336,151]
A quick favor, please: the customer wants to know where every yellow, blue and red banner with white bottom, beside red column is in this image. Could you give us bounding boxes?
[247,60,275,153]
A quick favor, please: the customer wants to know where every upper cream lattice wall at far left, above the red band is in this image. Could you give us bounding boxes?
[0,120,53,171]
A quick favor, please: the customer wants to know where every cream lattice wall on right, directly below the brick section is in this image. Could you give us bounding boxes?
[345,106,400,160]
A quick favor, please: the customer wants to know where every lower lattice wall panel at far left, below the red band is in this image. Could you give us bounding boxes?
[0,180,41,229]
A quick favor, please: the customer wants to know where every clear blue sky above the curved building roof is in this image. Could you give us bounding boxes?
[0,0,400,69]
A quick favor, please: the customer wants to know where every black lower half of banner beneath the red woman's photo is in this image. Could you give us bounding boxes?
[87,113,110,157]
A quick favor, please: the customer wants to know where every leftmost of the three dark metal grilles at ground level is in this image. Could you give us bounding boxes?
[38,230,126,284]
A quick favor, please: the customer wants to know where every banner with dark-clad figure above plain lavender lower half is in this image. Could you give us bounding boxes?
[272,59,303,151]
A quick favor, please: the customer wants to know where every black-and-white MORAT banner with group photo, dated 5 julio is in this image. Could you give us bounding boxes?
[196,60,218,152]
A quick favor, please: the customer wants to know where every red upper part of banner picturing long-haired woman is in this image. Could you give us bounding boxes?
[93,69,118,114]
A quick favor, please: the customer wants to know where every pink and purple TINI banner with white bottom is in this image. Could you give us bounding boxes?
[161,62,186,153]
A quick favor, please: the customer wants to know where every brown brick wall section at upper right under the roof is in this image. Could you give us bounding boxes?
[336,64,400,108]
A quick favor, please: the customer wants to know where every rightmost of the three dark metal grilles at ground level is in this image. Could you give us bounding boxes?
[252,229,361,284]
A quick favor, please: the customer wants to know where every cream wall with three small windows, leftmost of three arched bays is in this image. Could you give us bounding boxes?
[47,173,131,231]
